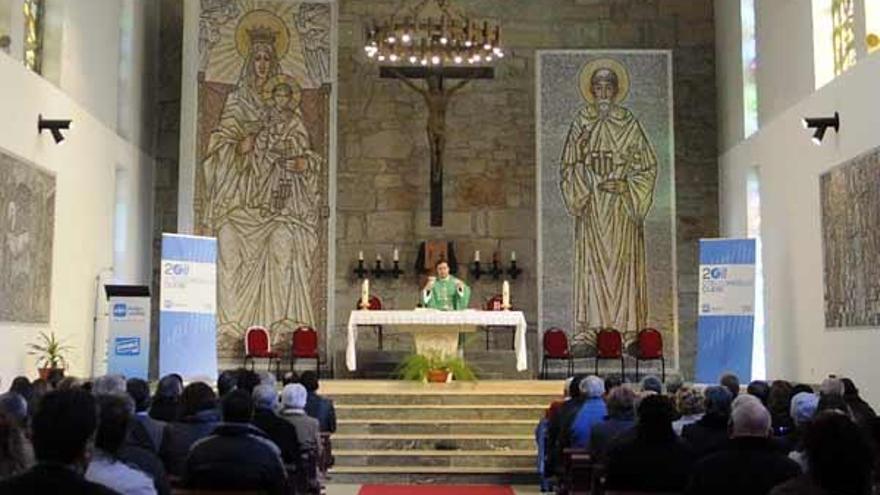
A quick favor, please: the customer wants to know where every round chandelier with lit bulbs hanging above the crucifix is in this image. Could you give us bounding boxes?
[364,0,504,67]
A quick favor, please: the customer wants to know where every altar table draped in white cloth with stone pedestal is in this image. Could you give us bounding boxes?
[345,308,528,371]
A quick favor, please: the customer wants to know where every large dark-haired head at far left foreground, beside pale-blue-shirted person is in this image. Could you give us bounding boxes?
[31,389,98,468]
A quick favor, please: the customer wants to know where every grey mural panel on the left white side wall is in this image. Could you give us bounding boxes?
[0,152,55,323]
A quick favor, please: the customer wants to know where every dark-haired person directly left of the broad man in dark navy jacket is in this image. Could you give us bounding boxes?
[160,382,220,476]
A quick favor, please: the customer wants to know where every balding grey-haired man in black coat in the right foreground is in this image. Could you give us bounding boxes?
[685,402,801,495]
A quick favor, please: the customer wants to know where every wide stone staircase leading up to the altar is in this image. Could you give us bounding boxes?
[322,380,562,484]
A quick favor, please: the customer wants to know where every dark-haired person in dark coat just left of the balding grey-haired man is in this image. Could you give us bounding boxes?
[681,385,738,458]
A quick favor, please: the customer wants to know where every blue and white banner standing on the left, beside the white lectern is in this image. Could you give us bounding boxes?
[159,234,217,381]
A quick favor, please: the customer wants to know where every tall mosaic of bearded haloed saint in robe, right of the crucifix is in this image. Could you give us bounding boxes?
[537,50,677,366]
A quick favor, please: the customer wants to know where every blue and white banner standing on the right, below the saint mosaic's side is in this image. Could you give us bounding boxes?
[696,239,756,383]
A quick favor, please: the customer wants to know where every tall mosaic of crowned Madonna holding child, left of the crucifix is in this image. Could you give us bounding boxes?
[193,0,332,358]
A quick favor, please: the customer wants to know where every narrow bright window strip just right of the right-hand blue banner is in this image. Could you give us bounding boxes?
[746,167,767,380]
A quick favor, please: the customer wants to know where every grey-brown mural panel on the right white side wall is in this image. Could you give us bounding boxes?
[819,148,880,329]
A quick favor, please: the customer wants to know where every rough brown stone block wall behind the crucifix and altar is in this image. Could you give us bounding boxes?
[334,0,718,376]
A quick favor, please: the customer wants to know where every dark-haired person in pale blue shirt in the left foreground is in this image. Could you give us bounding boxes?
[85,396,156,495]
